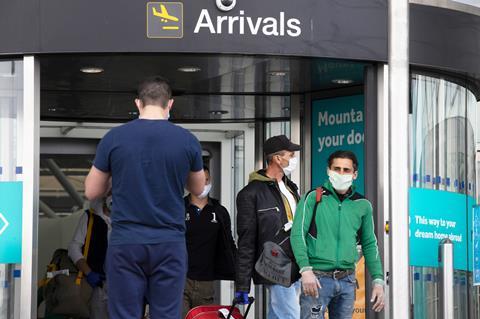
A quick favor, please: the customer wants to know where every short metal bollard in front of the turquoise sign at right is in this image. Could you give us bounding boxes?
[438,238,454,319]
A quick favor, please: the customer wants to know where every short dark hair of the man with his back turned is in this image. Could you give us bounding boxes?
[137,76,172,108]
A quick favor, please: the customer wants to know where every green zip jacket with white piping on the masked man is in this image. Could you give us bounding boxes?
[290,182,383,282]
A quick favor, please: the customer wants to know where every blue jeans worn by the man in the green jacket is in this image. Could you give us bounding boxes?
[300,274,357,319]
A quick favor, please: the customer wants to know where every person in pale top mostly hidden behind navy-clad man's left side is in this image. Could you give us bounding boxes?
[68,197,111,319]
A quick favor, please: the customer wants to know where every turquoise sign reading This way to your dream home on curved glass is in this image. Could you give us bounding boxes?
[409,188,475,270]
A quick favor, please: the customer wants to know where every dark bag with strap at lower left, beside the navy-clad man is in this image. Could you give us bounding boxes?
[42,210,93,318]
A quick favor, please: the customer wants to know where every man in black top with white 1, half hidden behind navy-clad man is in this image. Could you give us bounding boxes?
[183,167,236,317]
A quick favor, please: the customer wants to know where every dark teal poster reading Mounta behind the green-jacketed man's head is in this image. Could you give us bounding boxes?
[312,95,364,194]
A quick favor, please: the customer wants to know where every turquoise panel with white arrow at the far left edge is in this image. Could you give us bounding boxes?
[0,182,22,264]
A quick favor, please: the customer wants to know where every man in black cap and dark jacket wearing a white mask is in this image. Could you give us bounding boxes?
[235,135,301,319]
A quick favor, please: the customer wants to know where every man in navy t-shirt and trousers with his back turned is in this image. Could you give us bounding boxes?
[85,77,205,319]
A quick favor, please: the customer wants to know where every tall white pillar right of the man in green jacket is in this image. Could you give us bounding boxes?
[388,0,410,319]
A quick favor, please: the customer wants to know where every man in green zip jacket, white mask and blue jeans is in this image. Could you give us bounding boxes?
[290,151,384,319]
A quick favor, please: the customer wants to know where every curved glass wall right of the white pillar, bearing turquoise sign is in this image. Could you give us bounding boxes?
[410,74,479,319]
